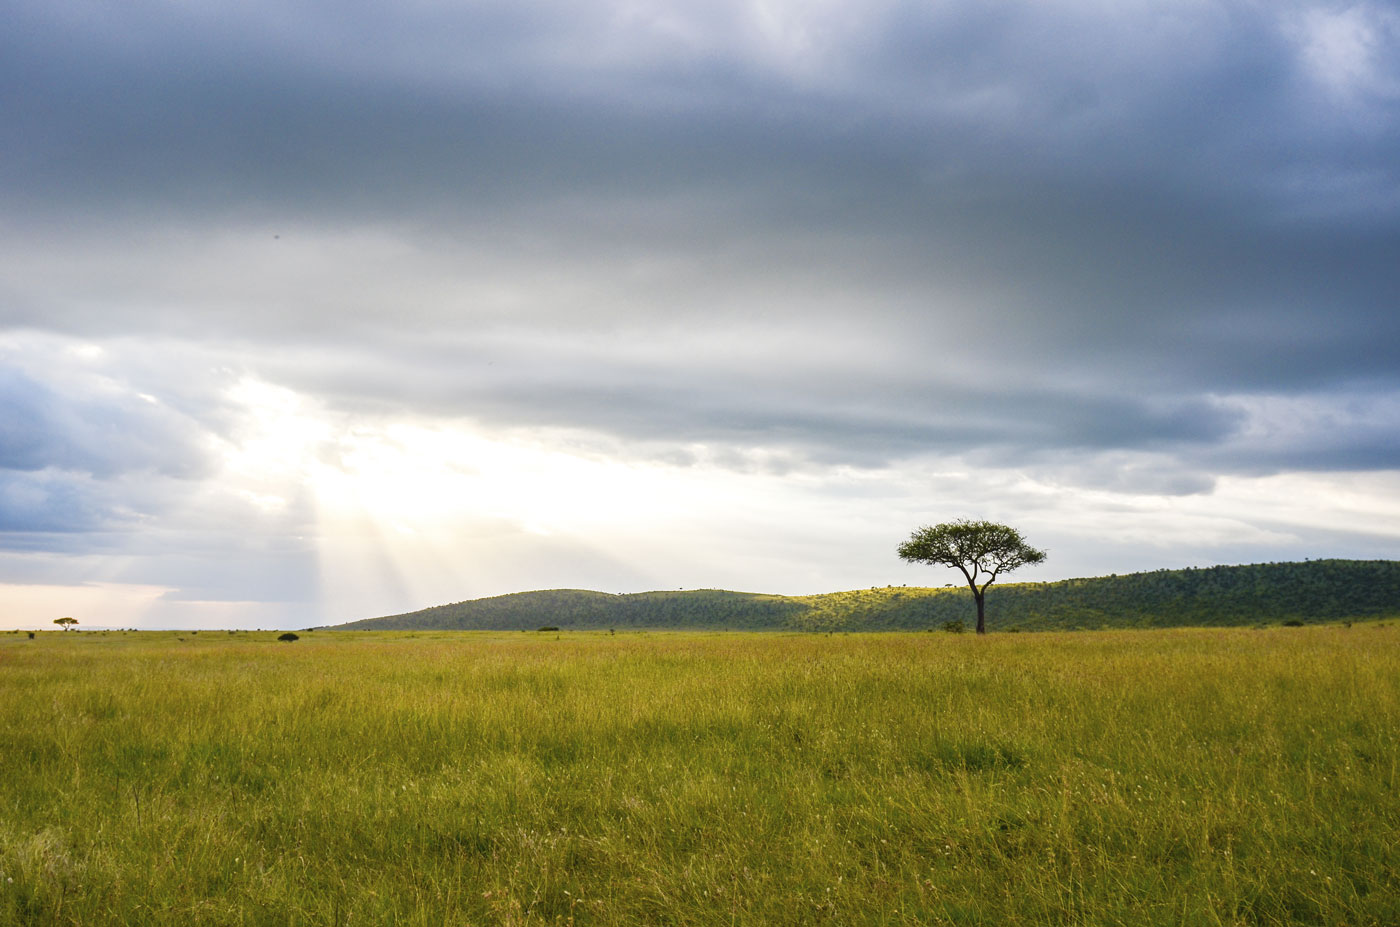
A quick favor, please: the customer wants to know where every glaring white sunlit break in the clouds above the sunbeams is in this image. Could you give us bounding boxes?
[224,379,692,535]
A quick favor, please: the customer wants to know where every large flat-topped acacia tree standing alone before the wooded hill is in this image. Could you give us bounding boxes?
[899,520,1046,634]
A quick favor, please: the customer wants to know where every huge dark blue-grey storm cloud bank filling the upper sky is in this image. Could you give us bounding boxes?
[0,3,1400,478]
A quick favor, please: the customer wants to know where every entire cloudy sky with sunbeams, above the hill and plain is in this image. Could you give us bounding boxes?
[0,0,1400,627]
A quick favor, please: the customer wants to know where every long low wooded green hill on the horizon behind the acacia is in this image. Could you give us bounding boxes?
[336,560,1400,632]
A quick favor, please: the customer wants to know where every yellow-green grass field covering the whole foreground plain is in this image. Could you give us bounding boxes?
[0,623,1400,926]
